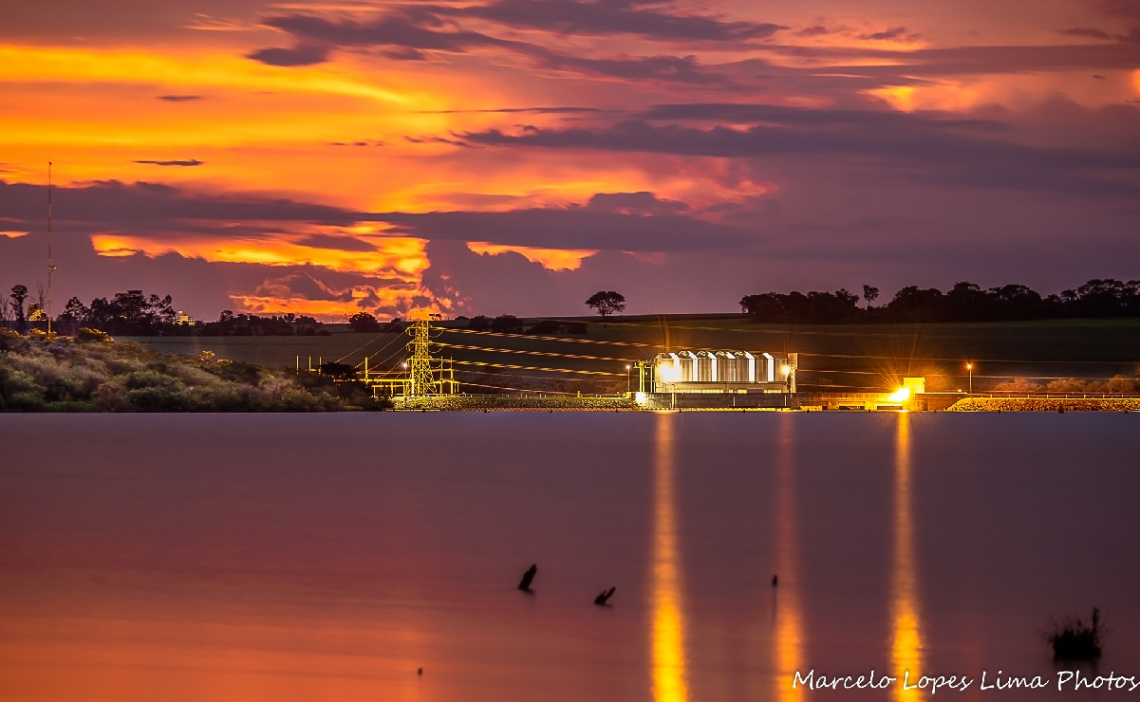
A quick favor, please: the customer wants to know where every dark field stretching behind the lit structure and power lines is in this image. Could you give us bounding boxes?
[124,315,1140,394]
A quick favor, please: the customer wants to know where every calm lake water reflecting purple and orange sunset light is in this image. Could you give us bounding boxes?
[0,413,1140,702]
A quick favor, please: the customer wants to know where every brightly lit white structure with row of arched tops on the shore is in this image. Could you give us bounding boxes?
[640,351,799,393]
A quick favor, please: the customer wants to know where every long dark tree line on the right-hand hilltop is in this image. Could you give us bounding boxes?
[740,278,1140,324]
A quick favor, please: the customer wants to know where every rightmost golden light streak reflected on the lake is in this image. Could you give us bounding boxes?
[890,413,923,702]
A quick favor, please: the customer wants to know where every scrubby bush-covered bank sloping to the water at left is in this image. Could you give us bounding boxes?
[0,329,391,411]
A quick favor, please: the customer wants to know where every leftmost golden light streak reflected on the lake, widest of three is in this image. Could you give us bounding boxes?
[650,413,689,702]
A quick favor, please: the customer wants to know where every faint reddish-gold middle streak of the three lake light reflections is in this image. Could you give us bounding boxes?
[773,415,805,702]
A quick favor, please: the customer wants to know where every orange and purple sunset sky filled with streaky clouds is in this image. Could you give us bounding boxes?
[0,0,1140,321]
